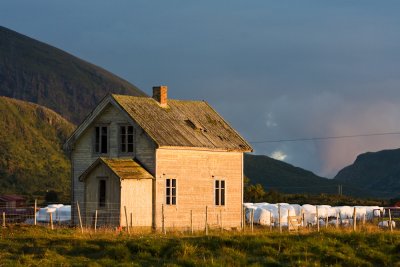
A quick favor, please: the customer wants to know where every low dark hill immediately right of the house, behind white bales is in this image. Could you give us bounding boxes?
[244,154,370,197]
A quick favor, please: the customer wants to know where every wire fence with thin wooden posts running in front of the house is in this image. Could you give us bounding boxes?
[0,202,400,235]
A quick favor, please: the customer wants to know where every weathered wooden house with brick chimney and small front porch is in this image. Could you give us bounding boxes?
[65,86,252,229]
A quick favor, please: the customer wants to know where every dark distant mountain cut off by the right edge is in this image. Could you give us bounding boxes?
[334,149,400,198]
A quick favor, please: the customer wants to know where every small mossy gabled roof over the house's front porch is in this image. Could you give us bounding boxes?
[79,158,154,181]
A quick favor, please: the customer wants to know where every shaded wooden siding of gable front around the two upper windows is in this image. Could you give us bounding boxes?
[71,104,155,224]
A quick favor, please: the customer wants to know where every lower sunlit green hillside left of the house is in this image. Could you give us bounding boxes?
[0,97,74,200]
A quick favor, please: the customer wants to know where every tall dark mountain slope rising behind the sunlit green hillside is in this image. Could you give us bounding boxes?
[0,26,146,124]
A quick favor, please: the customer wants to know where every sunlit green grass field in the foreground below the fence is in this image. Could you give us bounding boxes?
[0,226,400,266]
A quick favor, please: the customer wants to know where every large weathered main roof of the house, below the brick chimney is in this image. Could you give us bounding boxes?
[112,95,252,152]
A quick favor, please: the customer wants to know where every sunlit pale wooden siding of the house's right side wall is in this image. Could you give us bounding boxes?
[154,149,243,230]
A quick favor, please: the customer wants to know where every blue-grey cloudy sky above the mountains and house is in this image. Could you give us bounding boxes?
[0,0,400,178]
